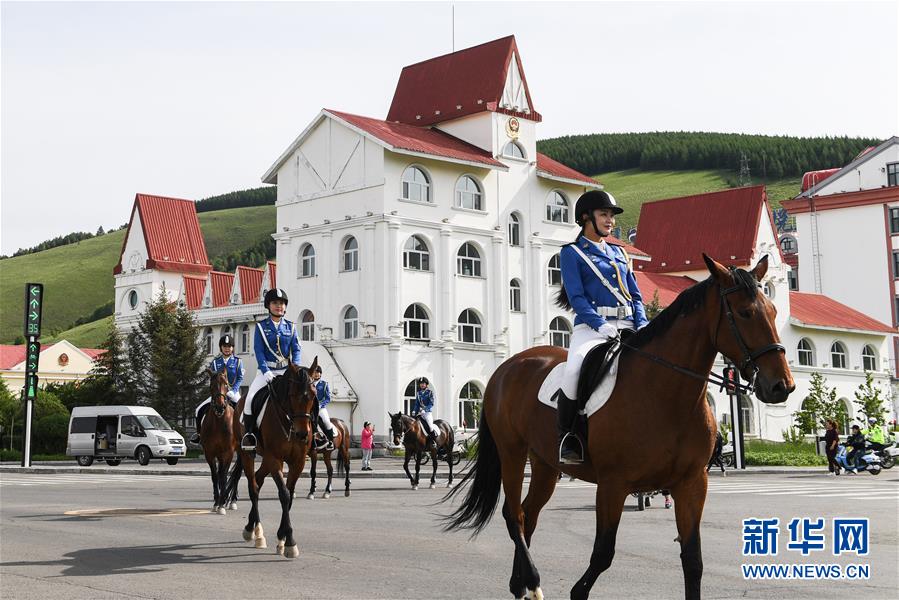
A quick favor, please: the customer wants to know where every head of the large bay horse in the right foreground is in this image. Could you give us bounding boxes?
[702,254,796,404]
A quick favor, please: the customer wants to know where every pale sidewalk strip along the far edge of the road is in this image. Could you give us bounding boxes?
[0,456,827,480]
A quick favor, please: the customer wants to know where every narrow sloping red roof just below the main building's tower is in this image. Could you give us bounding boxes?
[325,109,506,170]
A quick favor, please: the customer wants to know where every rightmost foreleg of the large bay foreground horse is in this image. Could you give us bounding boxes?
[671,472,708,600]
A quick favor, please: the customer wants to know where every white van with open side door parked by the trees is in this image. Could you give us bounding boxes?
[66,406,187,467]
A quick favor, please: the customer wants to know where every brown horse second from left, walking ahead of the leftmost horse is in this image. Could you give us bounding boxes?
[228,357,318,558]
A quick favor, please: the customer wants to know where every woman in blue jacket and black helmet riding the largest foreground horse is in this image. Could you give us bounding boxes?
[557,190,647,464]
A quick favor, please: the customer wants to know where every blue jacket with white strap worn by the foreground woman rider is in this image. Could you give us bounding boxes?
[560,236,648,330]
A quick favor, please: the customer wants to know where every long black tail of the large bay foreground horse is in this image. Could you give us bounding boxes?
[442,415,502,537]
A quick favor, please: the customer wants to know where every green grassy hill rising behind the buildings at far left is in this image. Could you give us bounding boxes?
[0,206,275,345]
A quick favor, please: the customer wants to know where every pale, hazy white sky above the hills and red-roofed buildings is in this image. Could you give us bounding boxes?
[0,0,899,254]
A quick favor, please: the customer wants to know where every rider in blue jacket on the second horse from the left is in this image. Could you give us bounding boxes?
[240,288,300,450]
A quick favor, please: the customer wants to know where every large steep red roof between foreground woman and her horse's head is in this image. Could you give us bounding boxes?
[637,185,777,273]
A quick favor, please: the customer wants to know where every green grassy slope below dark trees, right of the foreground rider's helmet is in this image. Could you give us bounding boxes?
[596,169,800,236]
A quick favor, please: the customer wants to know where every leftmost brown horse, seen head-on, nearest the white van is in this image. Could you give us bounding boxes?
[200,369,237,515]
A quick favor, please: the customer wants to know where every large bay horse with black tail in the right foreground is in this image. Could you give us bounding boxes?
[446,257,795,599]
